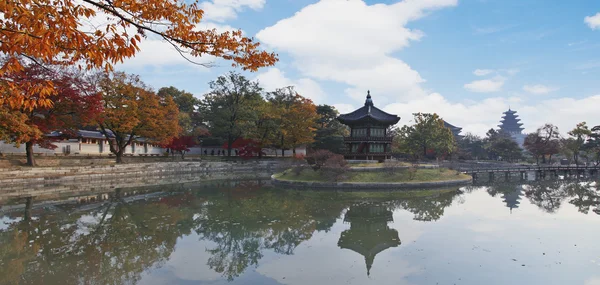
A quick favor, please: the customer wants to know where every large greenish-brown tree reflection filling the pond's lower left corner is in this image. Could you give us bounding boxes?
[0,191,191,284]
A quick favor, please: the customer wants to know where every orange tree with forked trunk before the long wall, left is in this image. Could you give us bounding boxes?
[95,72,180,163]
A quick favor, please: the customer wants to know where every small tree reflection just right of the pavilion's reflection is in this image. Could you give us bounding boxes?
[396,191,461,221]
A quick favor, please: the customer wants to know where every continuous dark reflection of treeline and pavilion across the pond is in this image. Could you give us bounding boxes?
[0,176,600,284]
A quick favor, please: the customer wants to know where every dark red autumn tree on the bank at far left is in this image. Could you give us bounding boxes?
[0,64,101,166]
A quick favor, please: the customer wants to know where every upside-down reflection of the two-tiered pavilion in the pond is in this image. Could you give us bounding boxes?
[338,204,400,275]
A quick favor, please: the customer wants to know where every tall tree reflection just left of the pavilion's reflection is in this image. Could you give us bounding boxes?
[195,191,343,280]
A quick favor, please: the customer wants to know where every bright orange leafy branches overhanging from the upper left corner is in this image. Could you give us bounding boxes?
[0,0,277,109]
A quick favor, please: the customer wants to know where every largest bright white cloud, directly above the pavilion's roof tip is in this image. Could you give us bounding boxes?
[256,0,457,103]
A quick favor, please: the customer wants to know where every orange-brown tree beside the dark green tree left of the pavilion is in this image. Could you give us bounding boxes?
[267,86,319,156]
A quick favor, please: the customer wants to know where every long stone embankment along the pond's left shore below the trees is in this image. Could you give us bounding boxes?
[0,160,290,201]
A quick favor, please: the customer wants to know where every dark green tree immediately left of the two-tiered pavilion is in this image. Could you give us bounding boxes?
[312,105,348,153]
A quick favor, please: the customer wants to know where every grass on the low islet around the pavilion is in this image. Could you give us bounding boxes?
[275,168,470,182]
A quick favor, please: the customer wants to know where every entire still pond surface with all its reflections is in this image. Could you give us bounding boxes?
[0,181,600,285]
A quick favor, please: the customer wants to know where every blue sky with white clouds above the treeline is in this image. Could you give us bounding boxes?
[117,0,600,135]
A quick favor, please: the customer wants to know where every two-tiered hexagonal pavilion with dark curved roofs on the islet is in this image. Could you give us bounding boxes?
[337,92,400,160]
